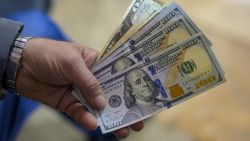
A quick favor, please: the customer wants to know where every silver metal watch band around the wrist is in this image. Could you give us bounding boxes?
[3,36,31,92]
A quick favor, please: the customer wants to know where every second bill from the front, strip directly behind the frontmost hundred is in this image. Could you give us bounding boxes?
[92,16,203,80]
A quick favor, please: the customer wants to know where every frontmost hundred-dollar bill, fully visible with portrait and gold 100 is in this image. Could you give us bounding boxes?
[98,34,225,133]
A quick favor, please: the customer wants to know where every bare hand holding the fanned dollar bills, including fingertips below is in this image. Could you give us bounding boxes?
[16,38,143,138]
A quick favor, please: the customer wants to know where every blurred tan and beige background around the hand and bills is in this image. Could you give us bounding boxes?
[8,0,250,141]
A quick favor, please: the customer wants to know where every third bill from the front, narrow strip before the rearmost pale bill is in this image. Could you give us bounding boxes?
[95,2,205,65]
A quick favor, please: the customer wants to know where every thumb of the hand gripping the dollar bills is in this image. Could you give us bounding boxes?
[69,56,105,110]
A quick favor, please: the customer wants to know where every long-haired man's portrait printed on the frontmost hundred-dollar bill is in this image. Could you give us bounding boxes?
[122,69,163,123]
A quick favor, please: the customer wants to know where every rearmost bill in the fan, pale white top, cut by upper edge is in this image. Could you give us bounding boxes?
[96,0,164,63]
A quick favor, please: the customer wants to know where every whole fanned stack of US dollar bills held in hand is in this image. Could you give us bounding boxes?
[72,0,225,133]
